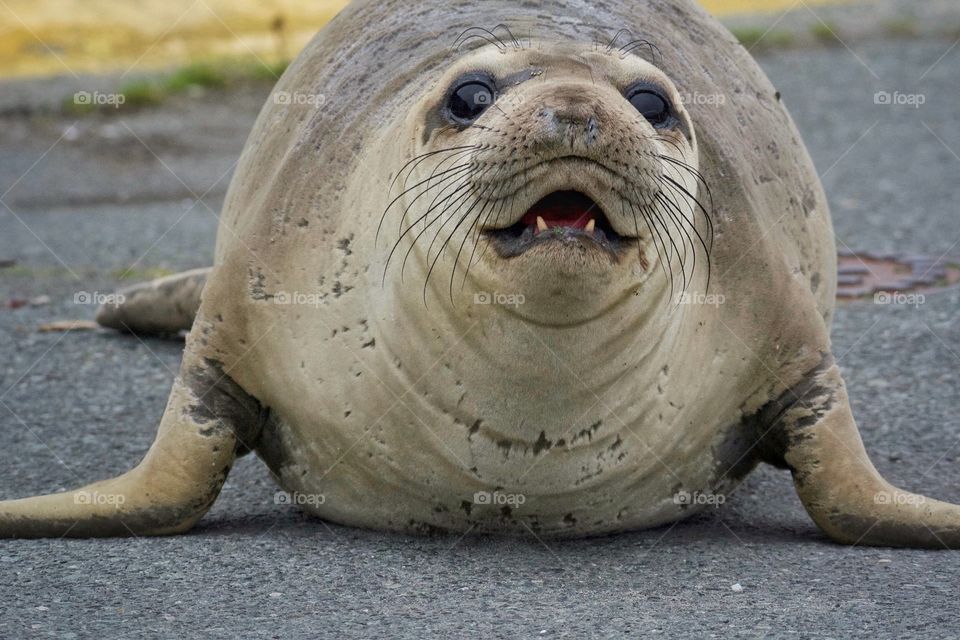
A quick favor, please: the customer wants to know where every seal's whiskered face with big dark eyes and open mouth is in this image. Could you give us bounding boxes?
[382,43,705,312]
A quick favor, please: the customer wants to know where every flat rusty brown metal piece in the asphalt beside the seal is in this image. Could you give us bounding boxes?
[837,251,960,300]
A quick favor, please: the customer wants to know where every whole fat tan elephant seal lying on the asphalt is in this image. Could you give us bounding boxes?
[0,0,960,548]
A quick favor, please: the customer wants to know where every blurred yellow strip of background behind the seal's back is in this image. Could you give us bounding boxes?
[0,0,856,76]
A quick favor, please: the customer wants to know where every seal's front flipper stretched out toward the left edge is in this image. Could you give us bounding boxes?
[0,344,262,538]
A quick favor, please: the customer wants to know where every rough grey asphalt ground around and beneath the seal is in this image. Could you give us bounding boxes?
[0,40,960,638]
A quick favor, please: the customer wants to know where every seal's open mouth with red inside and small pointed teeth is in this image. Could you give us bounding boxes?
[489,191,626,258]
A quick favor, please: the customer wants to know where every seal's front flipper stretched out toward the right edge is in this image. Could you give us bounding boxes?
[760,355,960,549]
